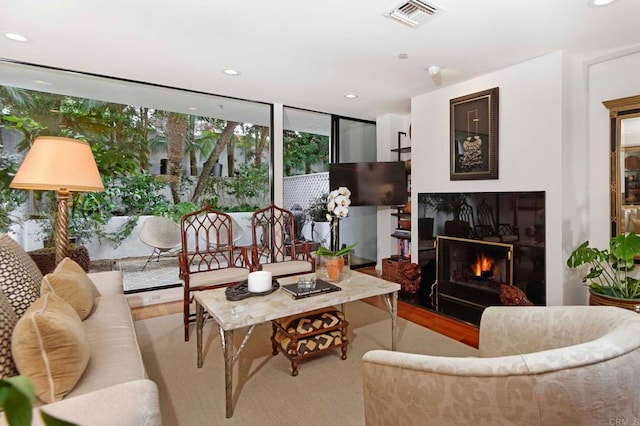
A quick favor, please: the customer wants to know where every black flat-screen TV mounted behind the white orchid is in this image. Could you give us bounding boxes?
[329,161,407,206]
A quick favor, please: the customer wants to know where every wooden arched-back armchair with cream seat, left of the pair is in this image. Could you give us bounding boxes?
[178,205,251,341]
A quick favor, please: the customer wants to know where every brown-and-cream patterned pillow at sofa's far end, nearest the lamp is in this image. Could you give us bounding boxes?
[0,234,42,317]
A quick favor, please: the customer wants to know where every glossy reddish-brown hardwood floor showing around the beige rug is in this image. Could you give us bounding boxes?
[131,268,479,348]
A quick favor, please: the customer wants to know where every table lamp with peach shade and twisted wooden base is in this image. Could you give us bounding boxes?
[9,136,104,265]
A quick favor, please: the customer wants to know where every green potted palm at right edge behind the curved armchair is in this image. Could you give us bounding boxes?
[567,233,640,312]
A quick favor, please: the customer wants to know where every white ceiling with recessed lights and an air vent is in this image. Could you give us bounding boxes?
[0,0,640,119]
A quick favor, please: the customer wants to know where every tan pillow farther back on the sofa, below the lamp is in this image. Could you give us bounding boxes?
[40,257,100,320]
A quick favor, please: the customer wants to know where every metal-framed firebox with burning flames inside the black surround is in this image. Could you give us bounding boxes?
[431,236,513,322]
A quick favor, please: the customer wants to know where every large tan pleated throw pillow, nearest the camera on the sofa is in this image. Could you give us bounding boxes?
[11,293,90,403]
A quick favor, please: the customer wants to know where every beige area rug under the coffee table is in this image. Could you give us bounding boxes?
[136,302,477,426]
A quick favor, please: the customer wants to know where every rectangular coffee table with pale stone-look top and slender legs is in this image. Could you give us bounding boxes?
[194,271,400,418]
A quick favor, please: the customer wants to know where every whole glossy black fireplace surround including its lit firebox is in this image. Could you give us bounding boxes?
[410,191,546,325]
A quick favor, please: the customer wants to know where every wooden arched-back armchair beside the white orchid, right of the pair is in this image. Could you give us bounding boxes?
[251,203,315,277]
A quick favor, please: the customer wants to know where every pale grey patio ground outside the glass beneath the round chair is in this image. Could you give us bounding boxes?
[118,257,182,294]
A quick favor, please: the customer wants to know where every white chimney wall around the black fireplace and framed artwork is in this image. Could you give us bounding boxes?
[411,52,564,305]
